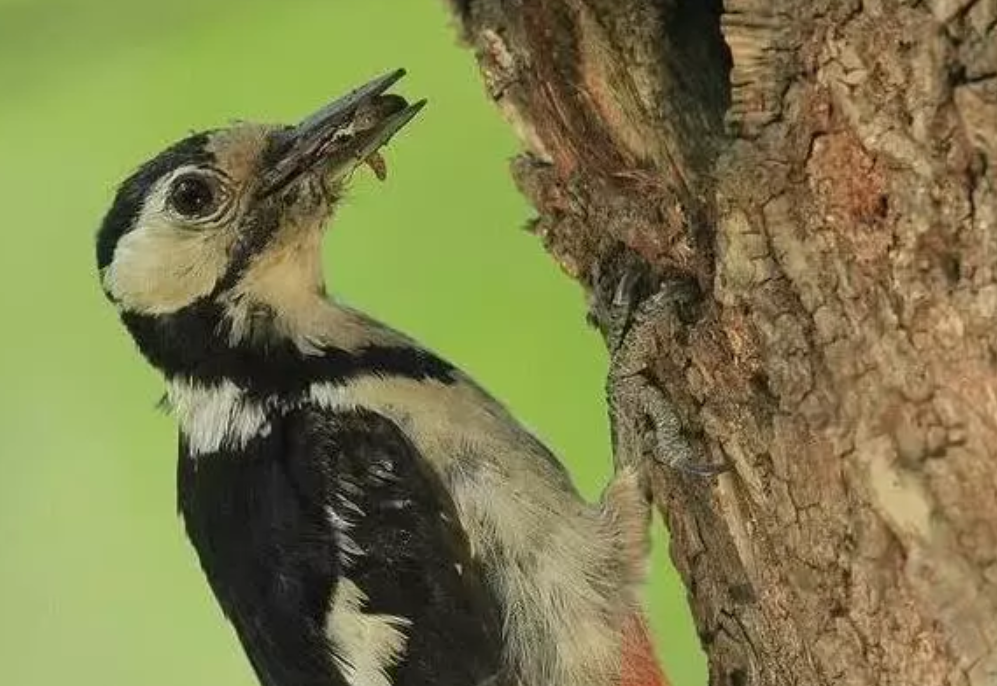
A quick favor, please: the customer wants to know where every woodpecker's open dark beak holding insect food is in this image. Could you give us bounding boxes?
[262,69,426,195]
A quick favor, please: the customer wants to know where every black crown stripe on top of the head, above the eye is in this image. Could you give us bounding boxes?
[97,131,214,269]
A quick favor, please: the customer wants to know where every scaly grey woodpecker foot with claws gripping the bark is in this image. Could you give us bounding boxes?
[592,250,727,476]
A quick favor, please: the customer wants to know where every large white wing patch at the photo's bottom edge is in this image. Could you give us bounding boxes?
[327,578,412,686]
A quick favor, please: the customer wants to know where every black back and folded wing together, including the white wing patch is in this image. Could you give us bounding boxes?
[178,404,500,686]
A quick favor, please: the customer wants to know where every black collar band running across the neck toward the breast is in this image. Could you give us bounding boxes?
[121,300,455,398]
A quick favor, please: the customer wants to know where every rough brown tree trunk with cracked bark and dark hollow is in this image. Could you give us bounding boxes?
[452,0,997,686]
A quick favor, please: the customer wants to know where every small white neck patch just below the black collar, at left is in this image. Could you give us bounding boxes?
[166,379,270,456]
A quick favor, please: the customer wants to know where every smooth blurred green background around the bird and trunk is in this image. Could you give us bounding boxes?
[0,0,705,686]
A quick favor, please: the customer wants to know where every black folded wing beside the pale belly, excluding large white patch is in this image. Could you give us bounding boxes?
[285,407,501,686]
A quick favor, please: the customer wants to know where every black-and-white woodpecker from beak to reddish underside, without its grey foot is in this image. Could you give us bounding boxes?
[96,70,664,686]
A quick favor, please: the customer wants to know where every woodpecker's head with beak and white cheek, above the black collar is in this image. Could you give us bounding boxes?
[97,70,424,326]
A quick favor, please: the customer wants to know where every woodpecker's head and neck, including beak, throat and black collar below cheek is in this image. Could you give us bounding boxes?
[97,70,425,385]
